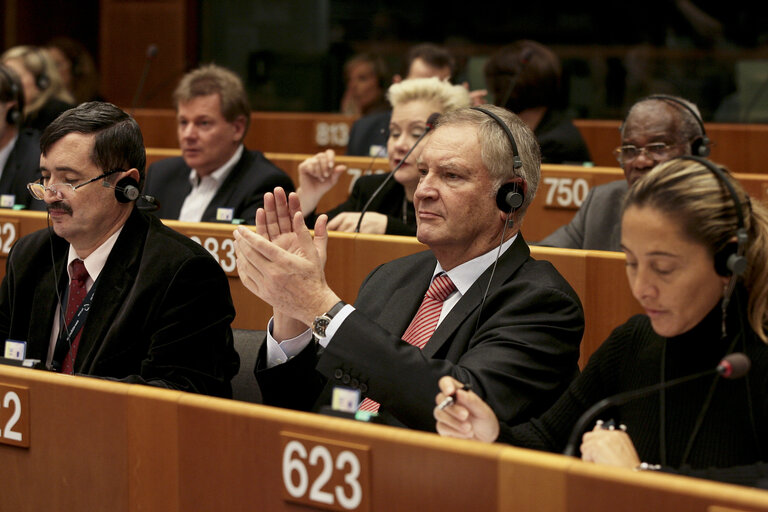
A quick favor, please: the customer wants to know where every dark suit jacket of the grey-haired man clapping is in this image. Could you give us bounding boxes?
[256,236,584,431]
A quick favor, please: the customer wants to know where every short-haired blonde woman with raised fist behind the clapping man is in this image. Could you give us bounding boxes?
[296,77,469,236]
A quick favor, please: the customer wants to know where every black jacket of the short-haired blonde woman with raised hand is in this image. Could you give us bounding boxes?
[307,173,416,236]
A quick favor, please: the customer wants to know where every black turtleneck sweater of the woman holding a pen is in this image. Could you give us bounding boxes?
[499,290,768,482]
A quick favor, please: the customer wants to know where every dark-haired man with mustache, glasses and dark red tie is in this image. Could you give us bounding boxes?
[0,102,239,397]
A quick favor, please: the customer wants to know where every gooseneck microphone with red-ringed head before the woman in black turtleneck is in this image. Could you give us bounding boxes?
[563,352,751,457]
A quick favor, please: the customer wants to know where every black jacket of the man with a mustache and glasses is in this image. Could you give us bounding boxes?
[0,209,239,397]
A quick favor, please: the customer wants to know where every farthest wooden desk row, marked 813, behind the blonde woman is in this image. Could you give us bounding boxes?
[133,109,768,174]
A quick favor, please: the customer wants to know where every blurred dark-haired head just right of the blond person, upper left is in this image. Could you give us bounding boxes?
[46,37,103,105]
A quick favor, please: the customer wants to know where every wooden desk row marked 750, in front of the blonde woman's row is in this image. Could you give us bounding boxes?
[147,148,768,242]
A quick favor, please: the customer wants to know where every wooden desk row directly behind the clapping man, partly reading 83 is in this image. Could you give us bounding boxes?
[0,210,642,366]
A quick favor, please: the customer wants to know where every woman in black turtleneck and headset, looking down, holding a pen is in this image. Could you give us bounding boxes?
[434,156,768,483]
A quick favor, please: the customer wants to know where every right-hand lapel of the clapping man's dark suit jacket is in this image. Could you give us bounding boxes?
[422,234,530,358]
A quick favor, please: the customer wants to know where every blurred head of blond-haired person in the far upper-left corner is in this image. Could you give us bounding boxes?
[0,46,74,132]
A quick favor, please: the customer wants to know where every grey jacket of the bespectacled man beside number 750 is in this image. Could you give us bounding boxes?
[538,180,628,251]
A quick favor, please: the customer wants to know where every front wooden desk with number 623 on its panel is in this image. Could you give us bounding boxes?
[0,366,768,512]
